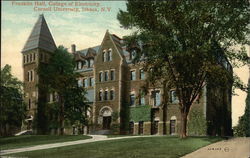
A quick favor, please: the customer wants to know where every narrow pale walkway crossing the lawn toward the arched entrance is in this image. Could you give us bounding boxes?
[0,135,158,155]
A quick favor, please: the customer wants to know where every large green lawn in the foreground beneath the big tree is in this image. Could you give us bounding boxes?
[11,136,221,158]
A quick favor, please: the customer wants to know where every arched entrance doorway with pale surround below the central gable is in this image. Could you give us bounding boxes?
[99,106,112,130]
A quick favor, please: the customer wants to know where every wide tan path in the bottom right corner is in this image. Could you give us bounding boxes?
[182,137,250,158]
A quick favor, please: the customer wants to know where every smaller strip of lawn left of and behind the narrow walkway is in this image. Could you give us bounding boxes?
[0,135,91,150]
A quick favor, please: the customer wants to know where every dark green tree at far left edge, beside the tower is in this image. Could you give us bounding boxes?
[0,65,26,136]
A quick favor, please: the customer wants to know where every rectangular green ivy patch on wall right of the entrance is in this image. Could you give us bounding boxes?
[129,105,151,122]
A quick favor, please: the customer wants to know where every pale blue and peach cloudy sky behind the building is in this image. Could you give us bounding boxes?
[1,1,250,125]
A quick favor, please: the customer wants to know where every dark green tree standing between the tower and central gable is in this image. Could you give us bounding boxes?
[38,46,88,135]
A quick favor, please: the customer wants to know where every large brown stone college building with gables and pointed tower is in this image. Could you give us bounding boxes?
[22,15,232,135]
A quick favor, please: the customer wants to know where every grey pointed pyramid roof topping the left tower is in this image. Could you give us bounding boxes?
[22,14,56,52]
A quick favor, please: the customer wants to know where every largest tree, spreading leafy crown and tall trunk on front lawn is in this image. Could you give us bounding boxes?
[117,0,250,138]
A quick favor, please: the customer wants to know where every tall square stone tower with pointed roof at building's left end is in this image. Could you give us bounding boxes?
[22,14,56,130]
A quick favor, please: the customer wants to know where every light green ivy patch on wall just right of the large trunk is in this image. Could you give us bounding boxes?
[188,109,207,135]
